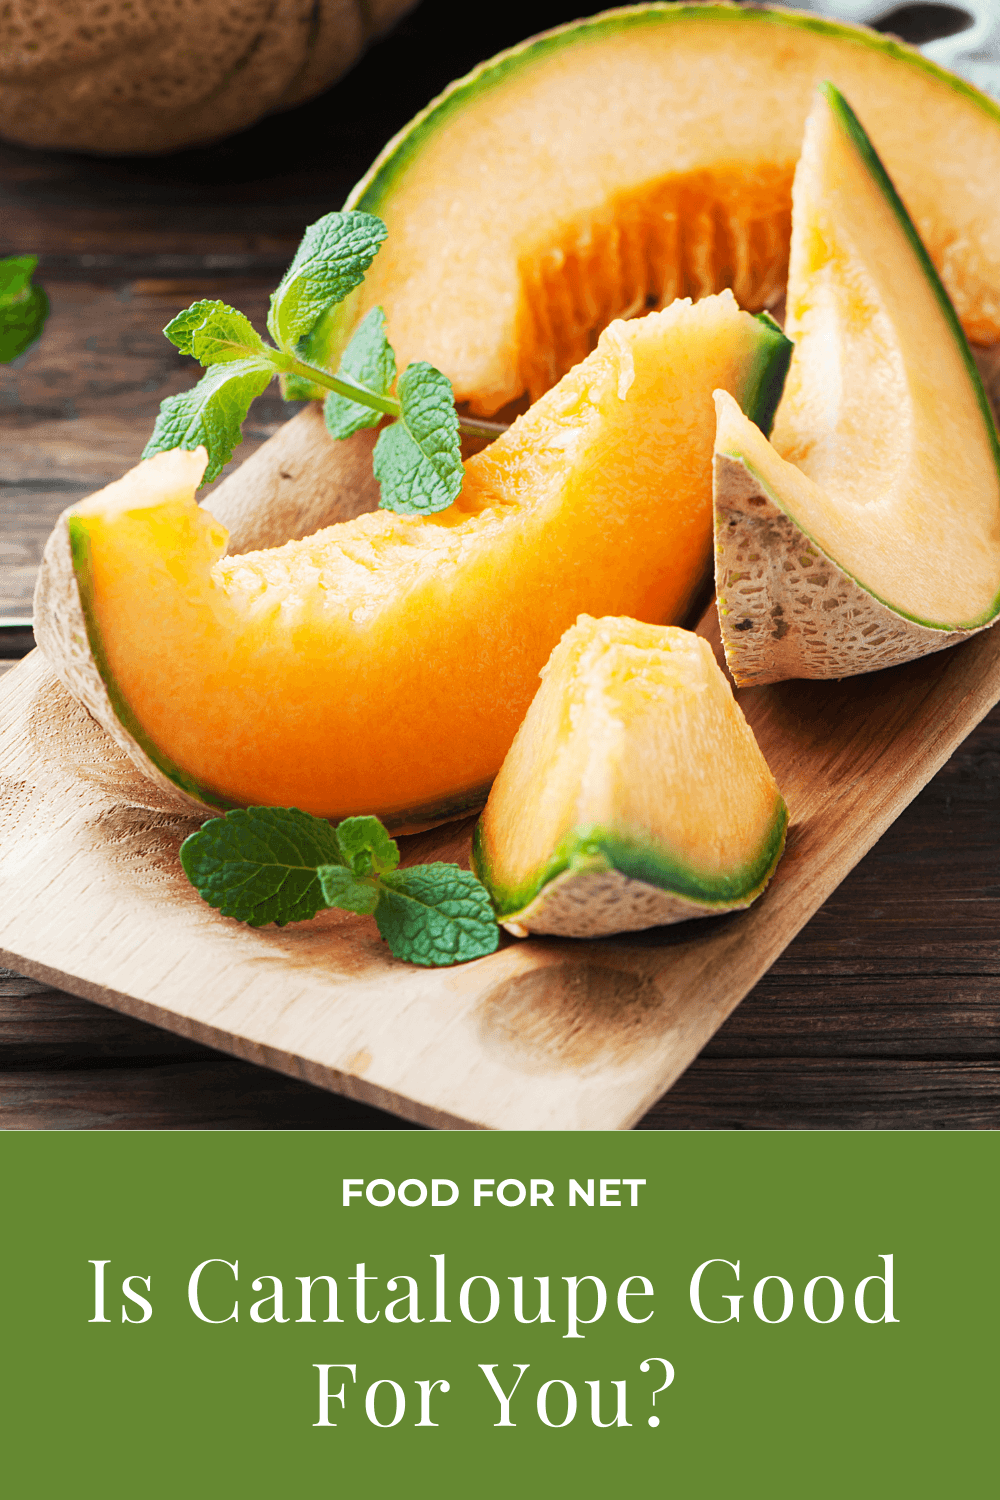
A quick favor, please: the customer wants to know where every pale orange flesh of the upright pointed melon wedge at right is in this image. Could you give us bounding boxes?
[767,83,1000,629]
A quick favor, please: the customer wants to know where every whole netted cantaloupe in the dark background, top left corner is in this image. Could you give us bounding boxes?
[0,0,414,155]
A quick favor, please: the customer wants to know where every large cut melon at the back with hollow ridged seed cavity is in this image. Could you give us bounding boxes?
[297,5,1000,416]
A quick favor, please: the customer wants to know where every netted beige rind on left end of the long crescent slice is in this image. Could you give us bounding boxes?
[33,507,222,818]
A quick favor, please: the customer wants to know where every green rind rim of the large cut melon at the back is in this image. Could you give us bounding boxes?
[285,3,1000,401]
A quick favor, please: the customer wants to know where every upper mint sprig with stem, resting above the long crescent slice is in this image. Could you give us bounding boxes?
[142,210,504,516]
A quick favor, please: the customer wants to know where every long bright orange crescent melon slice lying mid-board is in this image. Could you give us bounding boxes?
[34,293,789,830]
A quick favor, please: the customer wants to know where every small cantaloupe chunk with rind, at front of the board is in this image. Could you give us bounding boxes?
[472,615,789,938]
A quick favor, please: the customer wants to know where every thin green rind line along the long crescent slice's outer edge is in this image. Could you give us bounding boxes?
[69,516,490,833]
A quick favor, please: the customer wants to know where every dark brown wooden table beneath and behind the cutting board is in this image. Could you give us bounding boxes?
[0,0,1000,1130]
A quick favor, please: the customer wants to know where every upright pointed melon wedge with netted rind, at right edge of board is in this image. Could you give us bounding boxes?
[715,86,1000,683]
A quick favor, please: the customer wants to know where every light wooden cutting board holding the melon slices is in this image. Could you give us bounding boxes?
[7,444,1000,1130]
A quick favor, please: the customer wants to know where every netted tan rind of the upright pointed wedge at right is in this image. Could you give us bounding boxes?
[714,452,991,687]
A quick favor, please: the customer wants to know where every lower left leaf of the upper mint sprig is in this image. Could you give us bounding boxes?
[142,357,276,485]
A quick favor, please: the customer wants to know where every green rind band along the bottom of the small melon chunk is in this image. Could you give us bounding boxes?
[472,797,789,923]
